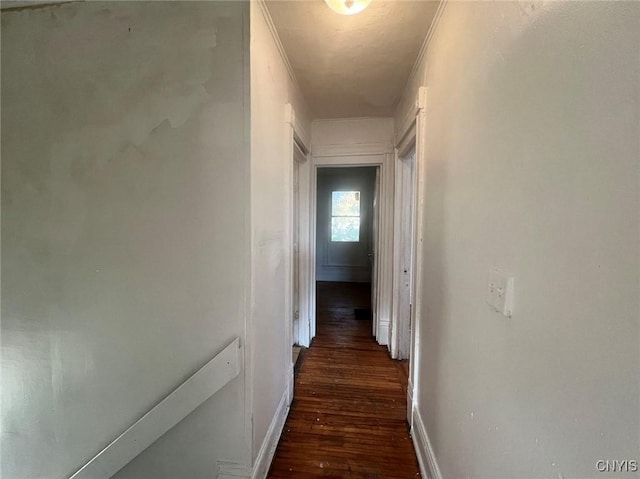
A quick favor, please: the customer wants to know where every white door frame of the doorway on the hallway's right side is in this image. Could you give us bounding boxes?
[393,86,427,428]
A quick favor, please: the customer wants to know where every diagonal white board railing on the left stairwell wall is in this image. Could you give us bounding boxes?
[70,338,241,479]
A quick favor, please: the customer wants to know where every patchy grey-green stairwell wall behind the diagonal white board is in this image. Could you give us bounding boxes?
[1,2,250,479]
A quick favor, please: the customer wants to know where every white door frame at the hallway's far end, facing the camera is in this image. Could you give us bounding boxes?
[308,143,394,345]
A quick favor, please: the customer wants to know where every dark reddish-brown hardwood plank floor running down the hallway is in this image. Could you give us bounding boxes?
[268,282,420,479]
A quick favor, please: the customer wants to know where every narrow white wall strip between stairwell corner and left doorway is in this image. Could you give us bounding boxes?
[250,2,309,459]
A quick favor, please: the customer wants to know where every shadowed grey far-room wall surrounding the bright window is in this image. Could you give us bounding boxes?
[316,166,376,283]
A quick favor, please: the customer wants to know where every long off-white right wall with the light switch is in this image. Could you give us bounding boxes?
[397,1,640,479]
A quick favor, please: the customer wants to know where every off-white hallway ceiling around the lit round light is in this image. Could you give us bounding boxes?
[266,0,439,119]
